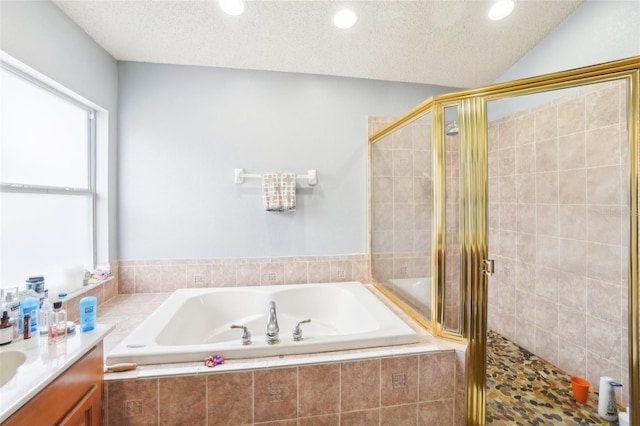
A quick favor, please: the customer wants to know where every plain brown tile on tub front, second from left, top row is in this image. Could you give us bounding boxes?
[158,376,207,425]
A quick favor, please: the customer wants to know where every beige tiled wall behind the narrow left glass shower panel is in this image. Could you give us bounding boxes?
[371,119,433,300]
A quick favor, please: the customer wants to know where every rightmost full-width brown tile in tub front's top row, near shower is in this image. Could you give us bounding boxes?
[418,351,455,401]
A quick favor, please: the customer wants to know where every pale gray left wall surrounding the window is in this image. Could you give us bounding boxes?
[0,0,118,261]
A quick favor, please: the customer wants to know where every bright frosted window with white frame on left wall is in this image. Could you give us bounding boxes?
[0,63,96,288]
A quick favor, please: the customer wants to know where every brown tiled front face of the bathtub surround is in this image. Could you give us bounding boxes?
[105,350,465,426]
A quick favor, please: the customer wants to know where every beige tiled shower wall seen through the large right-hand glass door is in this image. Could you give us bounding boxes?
[488,82,629,403]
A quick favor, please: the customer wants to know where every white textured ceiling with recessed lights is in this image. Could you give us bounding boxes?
[54,0,584,87]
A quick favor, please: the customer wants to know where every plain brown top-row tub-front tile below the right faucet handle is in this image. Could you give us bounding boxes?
[298,364,340,417]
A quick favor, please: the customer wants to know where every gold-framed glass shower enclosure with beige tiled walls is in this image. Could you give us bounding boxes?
[370,57,640,426]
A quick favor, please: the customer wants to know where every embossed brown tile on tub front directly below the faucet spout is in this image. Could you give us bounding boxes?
[253,368,298,423]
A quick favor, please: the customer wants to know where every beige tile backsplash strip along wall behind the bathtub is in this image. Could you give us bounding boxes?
[118,254,370,294]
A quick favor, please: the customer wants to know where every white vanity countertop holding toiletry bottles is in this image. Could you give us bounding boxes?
[0,324,115,423]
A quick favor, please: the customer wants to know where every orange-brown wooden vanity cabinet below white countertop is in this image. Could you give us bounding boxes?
[4,342,104,426]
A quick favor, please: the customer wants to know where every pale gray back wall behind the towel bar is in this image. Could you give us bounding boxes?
[118,62,452,260]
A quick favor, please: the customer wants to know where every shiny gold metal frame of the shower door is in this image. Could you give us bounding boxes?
[369,56,640,426]
